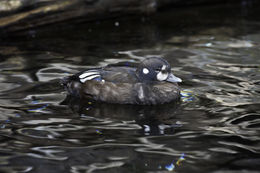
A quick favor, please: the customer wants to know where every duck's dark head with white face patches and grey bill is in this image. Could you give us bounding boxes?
[136,57,182,83]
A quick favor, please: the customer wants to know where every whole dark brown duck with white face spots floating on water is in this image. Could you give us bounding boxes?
[61,57,182,105]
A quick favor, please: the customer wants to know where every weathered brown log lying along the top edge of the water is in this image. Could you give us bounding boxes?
[0,0,237,32]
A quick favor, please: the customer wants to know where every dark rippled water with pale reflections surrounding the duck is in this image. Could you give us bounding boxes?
[0,1,260,173]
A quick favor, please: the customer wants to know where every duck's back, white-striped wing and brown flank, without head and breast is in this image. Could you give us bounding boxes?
[62,65,138,103]
